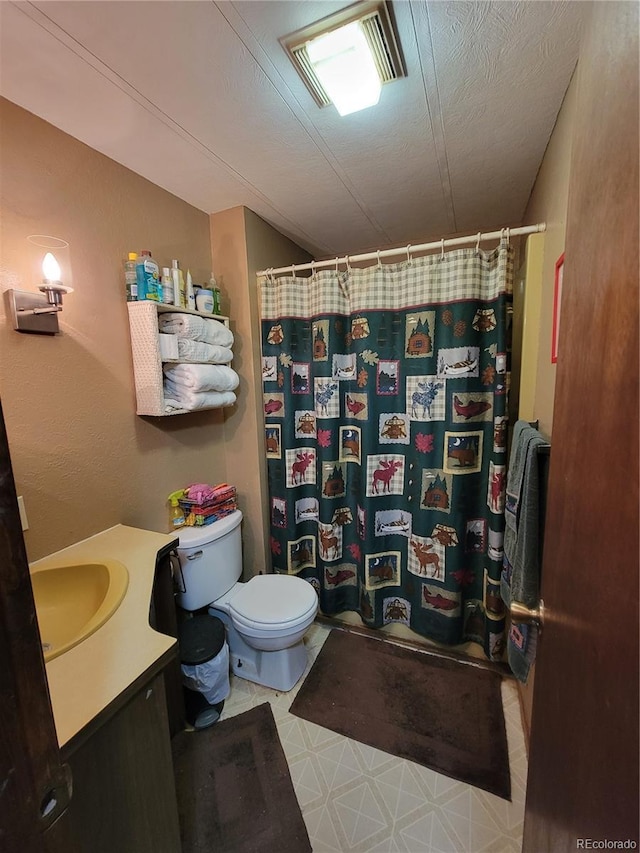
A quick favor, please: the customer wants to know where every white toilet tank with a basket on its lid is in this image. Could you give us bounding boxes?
[175,510,242,610]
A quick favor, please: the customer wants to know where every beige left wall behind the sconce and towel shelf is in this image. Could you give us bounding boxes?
[0,100,230,560]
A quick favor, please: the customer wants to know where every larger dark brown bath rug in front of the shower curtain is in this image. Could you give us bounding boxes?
[290,630,511,800]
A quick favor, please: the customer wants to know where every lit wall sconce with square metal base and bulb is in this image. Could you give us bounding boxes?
[6,244,73,335]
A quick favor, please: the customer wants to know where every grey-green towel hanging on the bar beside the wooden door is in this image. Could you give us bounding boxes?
[500,421,546,682]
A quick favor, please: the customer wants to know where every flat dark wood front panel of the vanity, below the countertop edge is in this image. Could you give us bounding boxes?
[69,674,181,853]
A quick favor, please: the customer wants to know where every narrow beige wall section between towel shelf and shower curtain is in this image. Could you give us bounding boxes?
[210,207,311,578]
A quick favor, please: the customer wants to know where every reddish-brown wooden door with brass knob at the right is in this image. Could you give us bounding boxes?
[523,3,638,853]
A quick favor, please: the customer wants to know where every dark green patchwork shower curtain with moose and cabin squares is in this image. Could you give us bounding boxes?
[261,241,513,659]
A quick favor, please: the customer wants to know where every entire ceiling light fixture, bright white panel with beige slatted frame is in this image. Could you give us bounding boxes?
[280,0,404,116]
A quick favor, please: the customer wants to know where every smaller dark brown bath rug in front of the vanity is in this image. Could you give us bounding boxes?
[172,702,311,853]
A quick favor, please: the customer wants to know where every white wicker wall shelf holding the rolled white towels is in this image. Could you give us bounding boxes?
[127,300,229,417]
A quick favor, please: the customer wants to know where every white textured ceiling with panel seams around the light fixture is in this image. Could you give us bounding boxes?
[0,0,586,258]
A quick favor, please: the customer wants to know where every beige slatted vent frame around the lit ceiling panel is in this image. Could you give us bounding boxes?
[280,0,405,107]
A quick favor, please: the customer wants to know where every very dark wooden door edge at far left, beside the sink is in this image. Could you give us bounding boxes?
[0,407,76,853]
